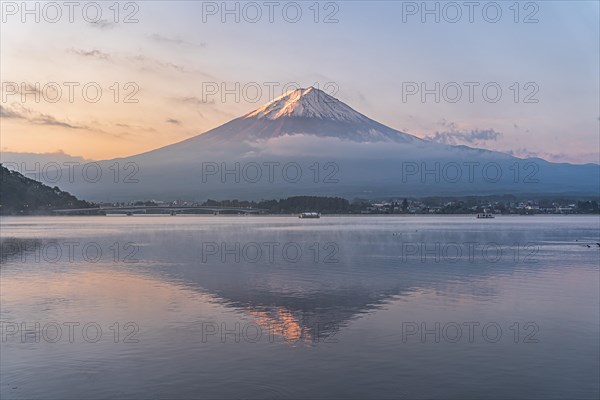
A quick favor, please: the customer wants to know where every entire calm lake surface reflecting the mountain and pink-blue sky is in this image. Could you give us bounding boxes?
[0,216,600,399]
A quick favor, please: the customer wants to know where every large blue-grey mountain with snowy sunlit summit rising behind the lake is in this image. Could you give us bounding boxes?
[16,88,600,201]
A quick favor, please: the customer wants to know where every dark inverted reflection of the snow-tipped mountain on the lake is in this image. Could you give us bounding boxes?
[5,216,598,342]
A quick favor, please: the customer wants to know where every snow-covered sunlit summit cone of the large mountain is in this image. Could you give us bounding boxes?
[242,86,367,122]
